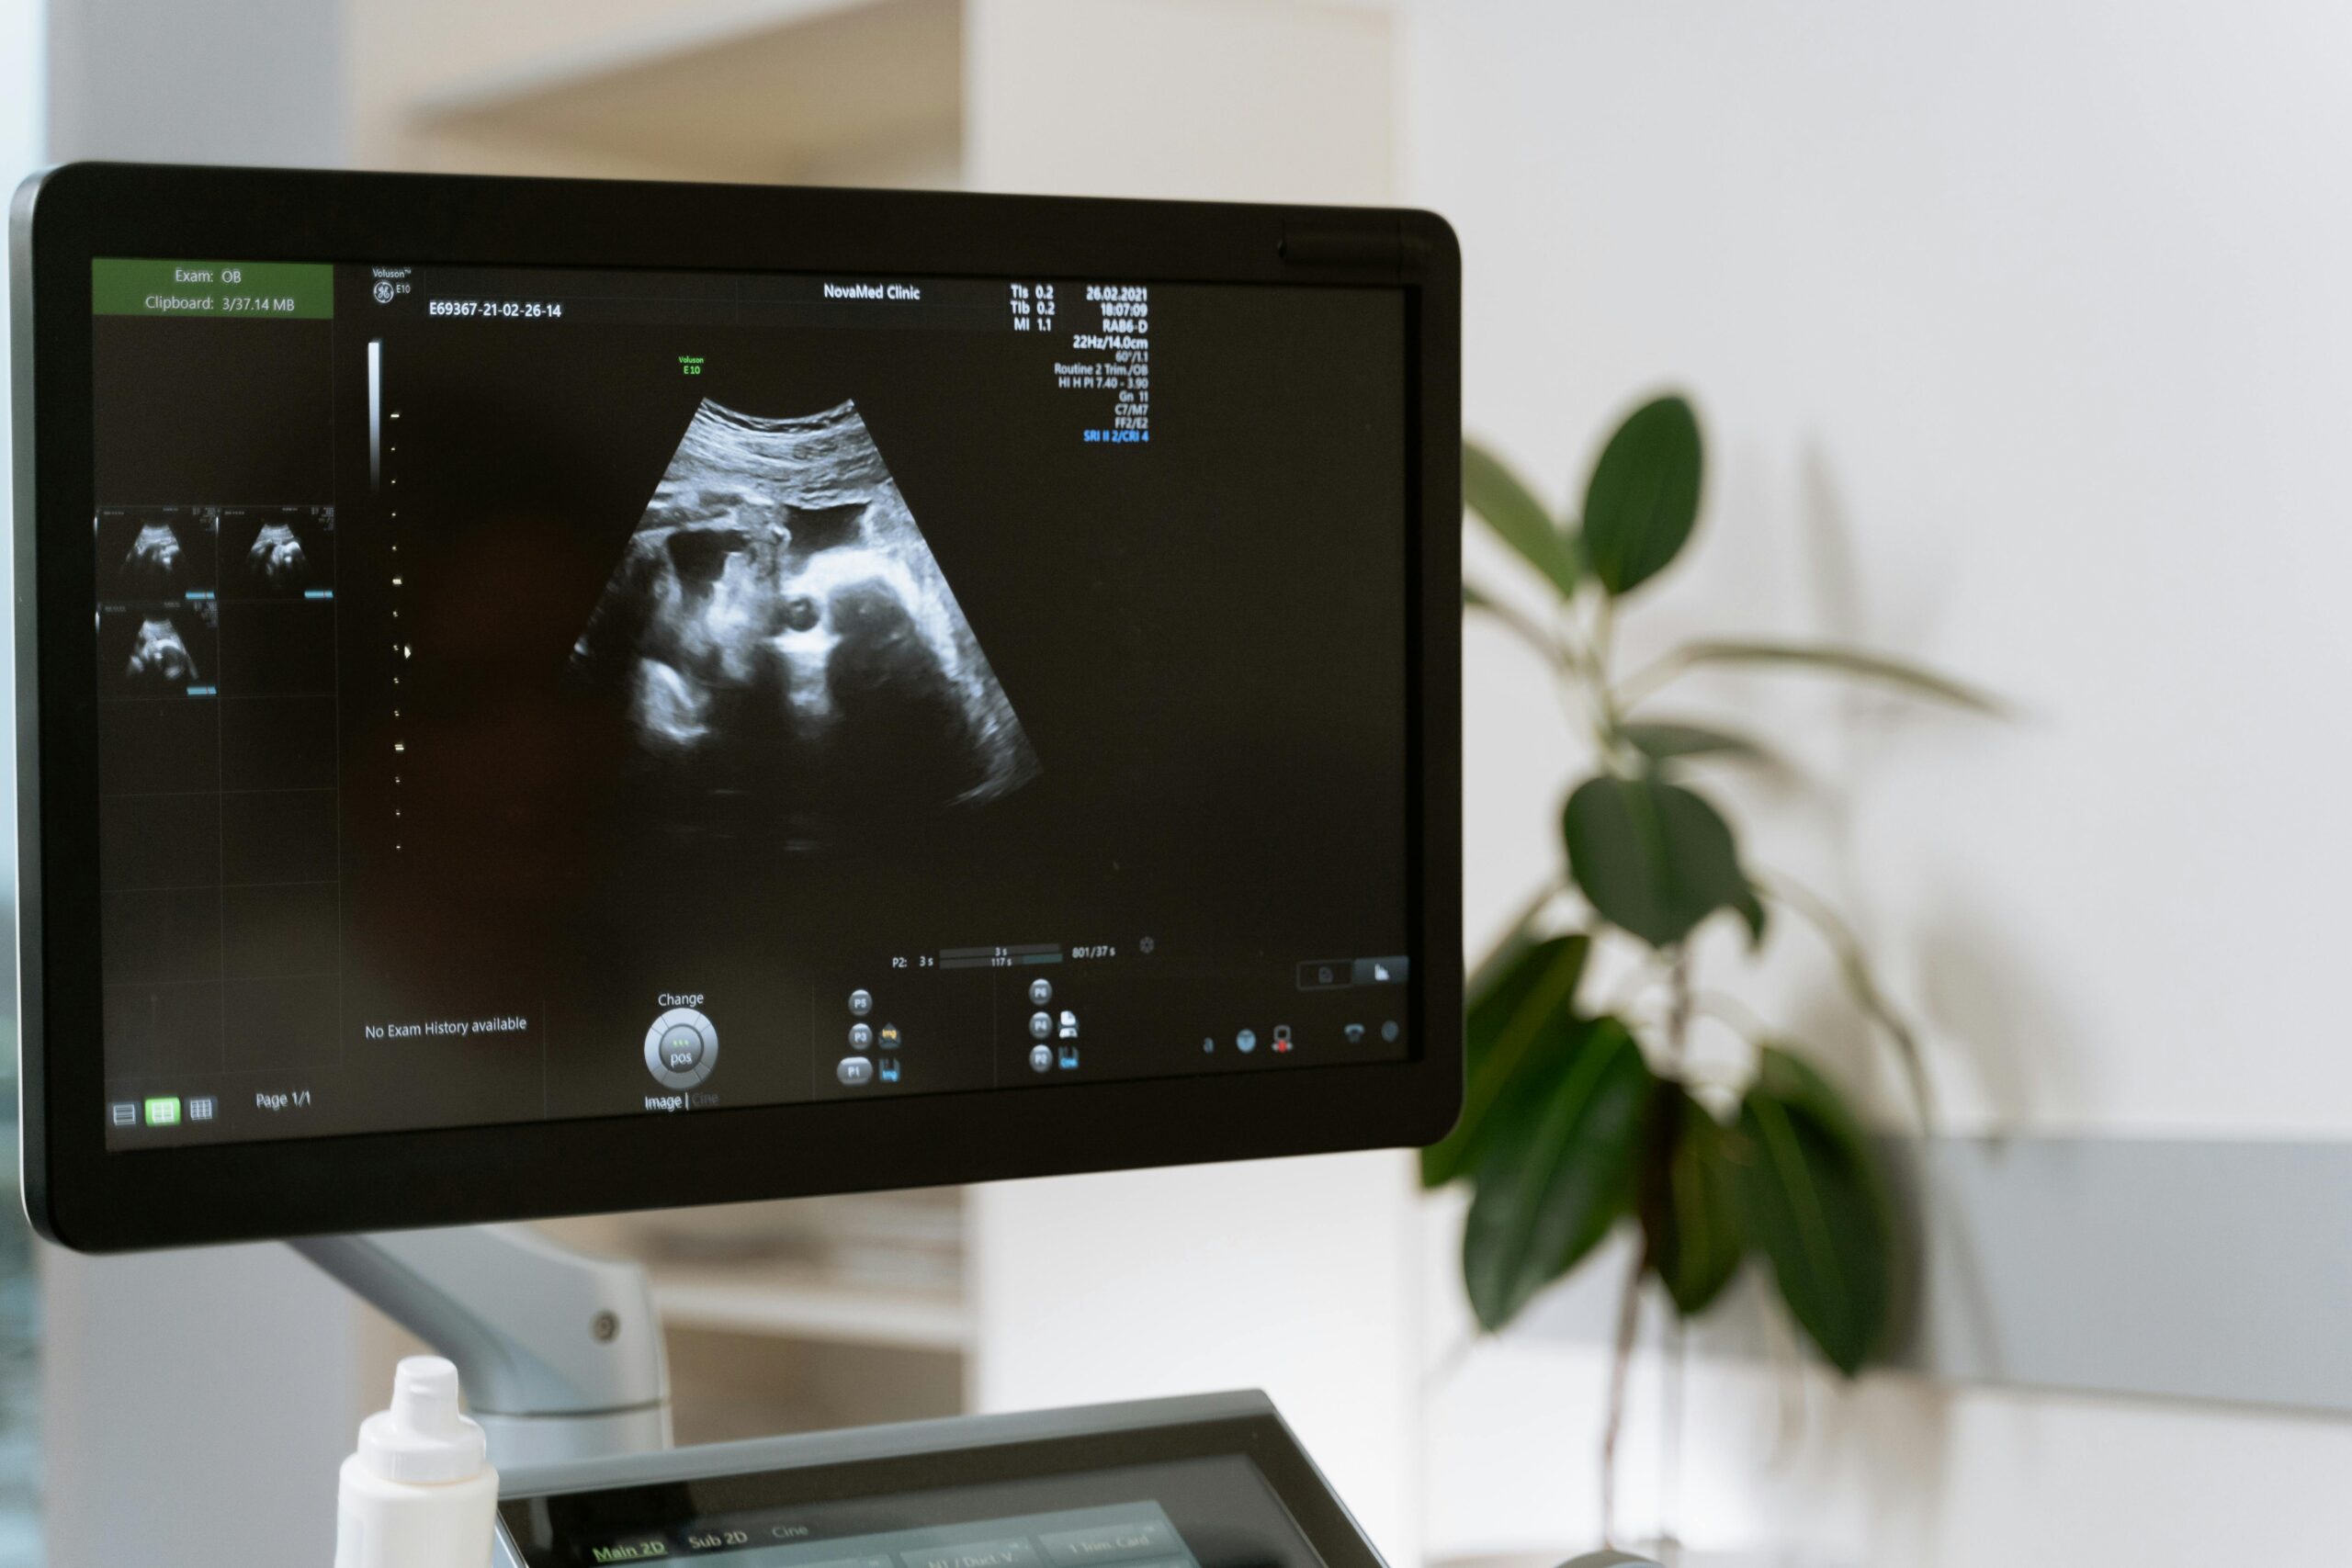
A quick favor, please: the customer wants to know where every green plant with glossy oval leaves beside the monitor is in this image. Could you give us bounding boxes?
[1420,398,1995,1535]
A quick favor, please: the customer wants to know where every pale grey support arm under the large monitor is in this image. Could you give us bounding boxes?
[287,1224,671,1470]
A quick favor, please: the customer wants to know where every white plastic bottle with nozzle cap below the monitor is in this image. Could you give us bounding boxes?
[334,1357,499,1568]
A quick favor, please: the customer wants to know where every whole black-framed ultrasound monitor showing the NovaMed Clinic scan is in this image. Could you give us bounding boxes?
[12,164,1461,1251]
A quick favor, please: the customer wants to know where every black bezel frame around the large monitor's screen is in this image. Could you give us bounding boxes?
[9,164,1463,1251]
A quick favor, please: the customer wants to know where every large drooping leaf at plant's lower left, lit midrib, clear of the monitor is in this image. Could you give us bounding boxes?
[1463,1018,1656,1331]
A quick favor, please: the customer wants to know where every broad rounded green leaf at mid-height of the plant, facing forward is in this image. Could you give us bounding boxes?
[1559,773,1764,947]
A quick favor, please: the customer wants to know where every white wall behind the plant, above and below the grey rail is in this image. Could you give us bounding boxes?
[1404,0,2352,1565]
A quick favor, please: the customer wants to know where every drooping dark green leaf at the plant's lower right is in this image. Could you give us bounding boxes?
[1736,1046,1895,1378]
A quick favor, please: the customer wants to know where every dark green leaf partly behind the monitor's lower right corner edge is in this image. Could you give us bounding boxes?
[1420,926,1592,1187]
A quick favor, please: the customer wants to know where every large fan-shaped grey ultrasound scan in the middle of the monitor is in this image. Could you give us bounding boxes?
[571,400,1040,844]
